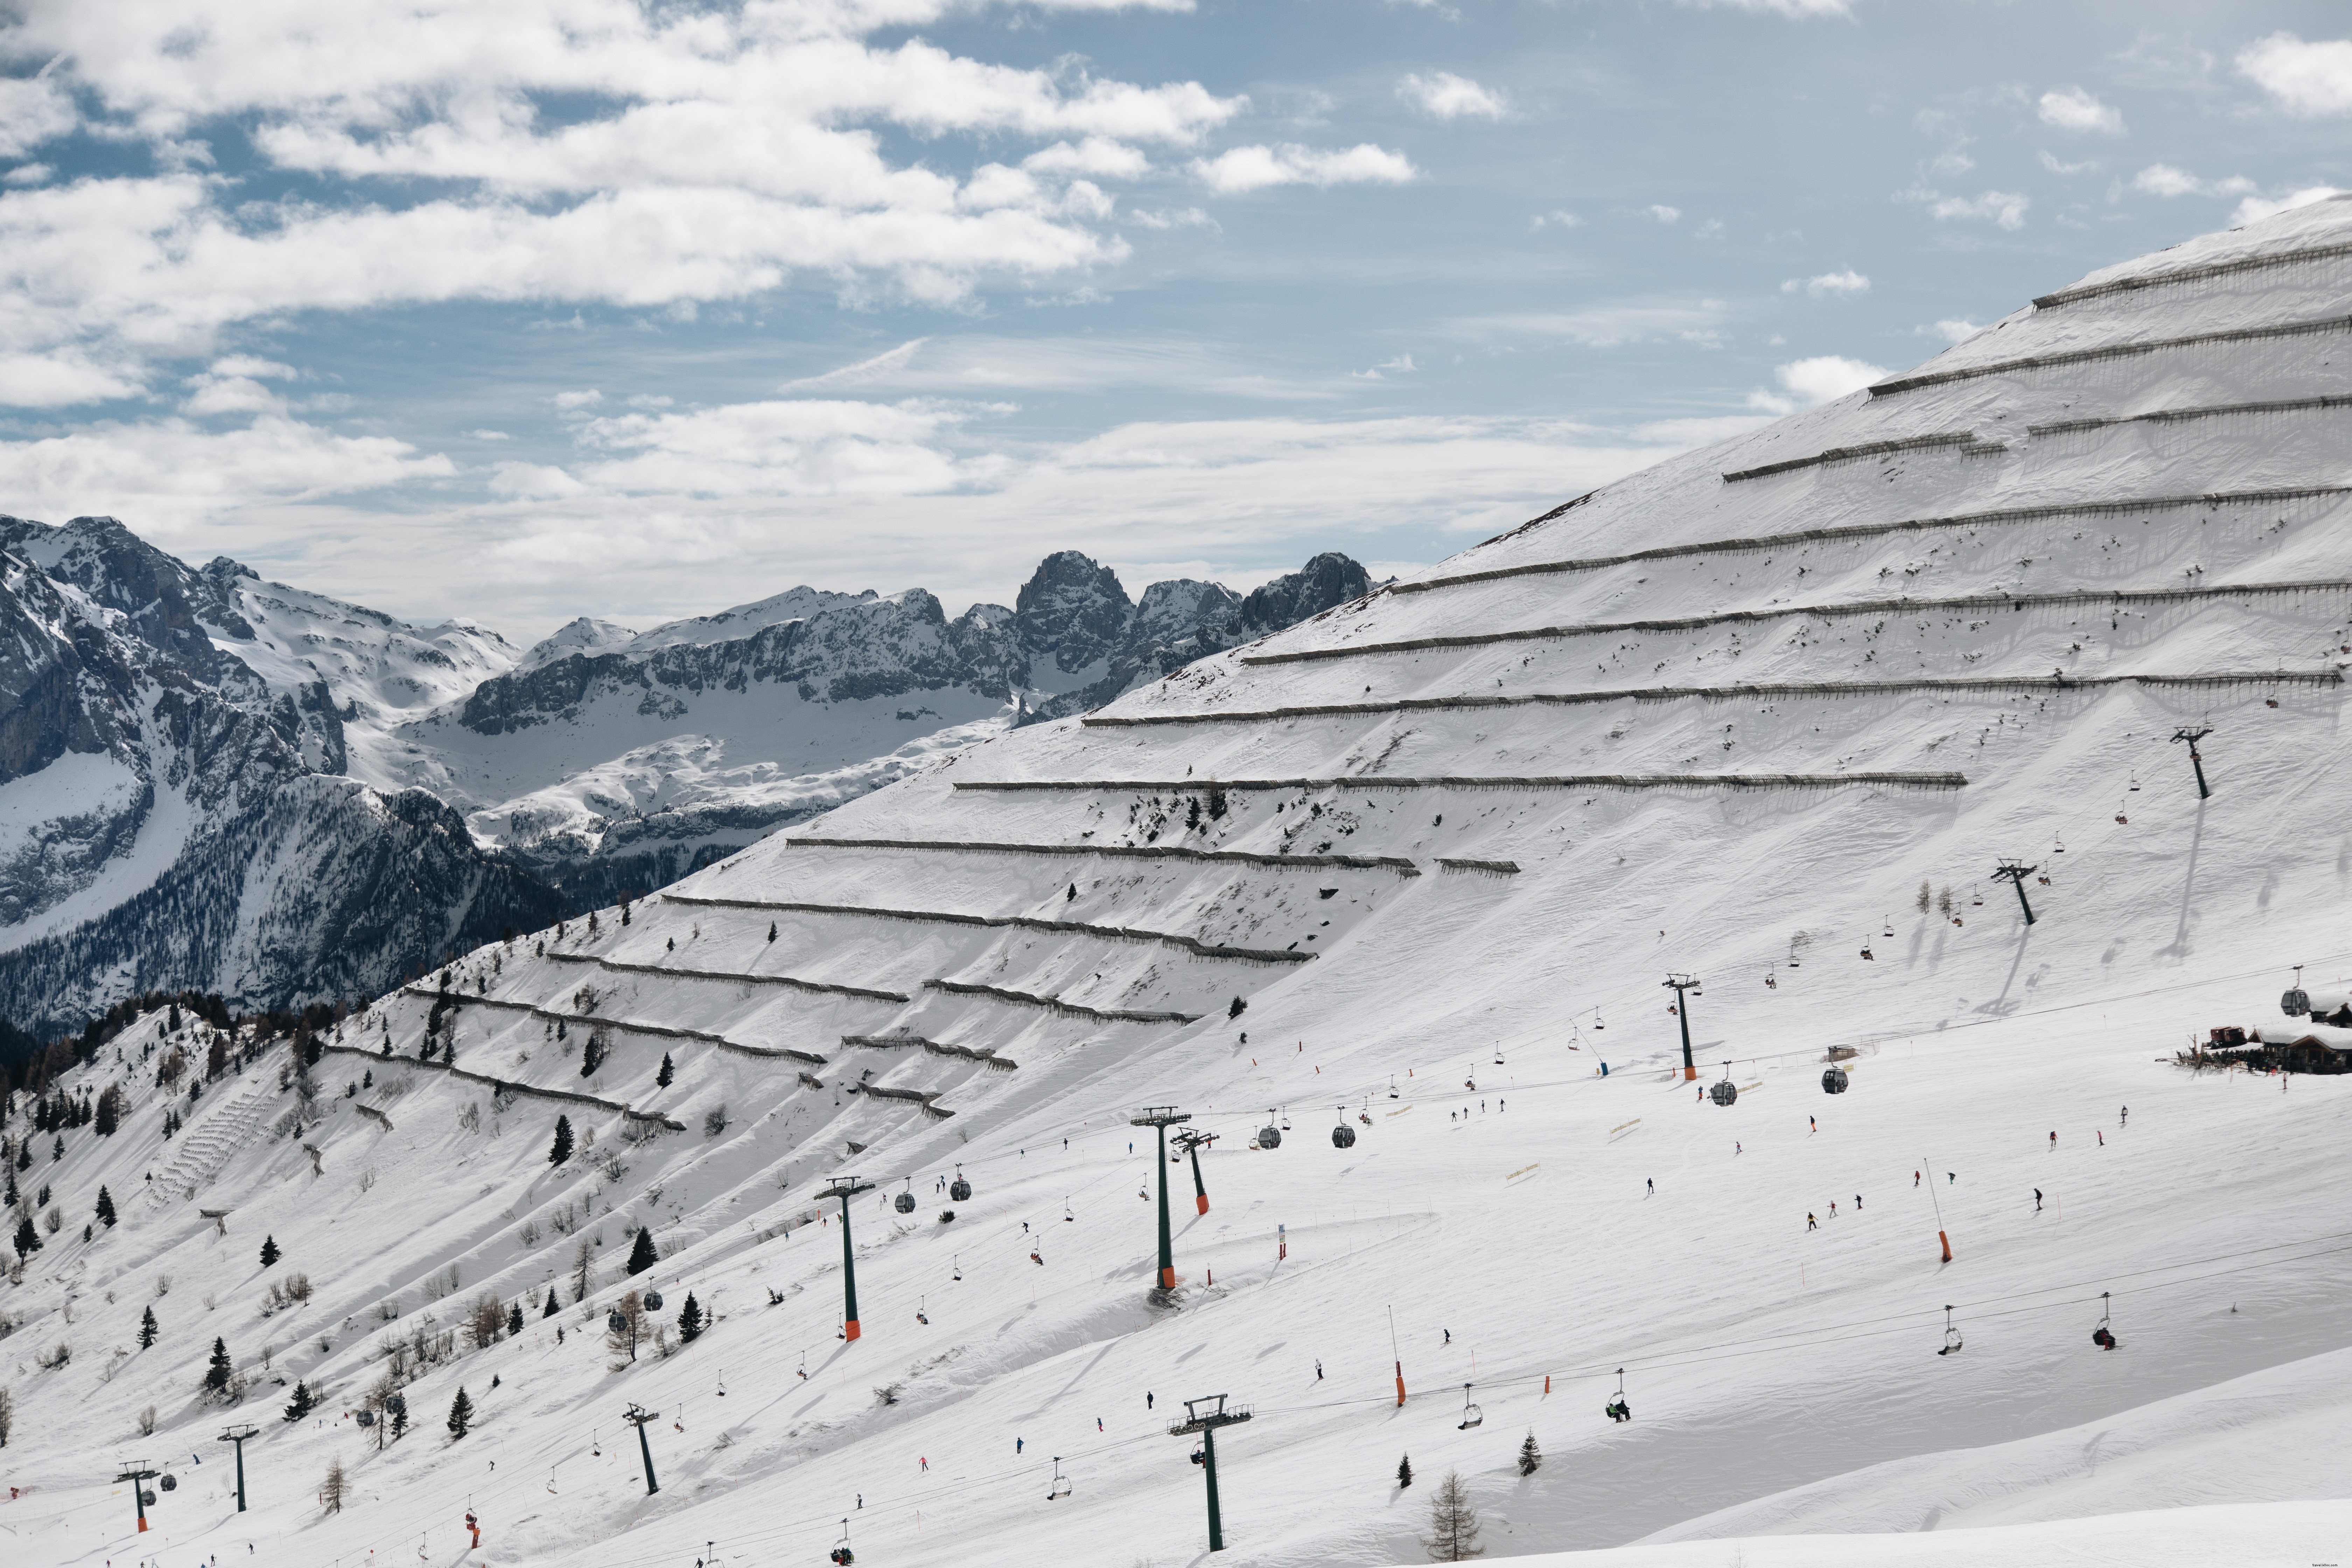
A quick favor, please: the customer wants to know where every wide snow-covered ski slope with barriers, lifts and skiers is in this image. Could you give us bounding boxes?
[0,200,2352,1568]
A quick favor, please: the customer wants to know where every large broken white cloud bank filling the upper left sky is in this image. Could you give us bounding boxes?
[0,0,1251,404]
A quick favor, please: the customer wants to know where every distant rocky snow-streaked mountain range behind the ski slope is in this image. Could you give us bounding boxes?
[0,517,1369,1032]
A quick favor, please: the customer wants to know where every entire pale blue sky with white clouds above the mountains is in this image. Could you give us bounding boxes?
[0,0,2352,639]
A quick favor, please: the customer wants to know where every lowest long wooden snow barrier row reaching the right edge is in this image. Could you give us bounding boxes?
[1077,670,2343,729]
